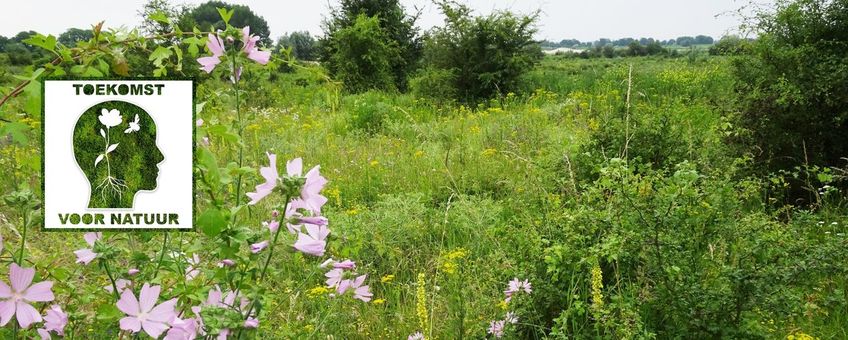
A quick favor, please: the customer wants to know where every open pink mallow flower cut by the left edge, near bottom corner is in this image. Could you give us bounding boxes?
[0,263,54,328]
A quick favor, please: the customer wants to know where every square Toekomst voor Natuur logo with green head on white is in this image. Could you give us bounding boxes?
[43,79,194,229]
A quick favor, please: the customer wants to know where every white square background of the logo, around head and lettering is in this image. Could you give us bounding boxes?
[44,80,194,229]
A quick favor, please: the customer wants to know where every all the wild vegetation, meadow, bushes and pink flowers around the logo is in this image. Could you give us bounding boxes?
[0,0,848,339]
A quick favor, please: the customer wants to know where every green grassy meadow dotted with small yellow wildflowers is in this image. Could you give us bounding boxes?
[0,13,848,339]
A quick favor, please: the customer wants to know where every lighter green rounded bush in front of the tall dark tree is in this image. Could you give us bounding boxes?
[325,14,401,92]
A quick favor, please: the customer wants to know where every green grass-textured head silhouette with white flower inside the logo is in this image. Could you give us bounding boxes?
[74,100,165,208]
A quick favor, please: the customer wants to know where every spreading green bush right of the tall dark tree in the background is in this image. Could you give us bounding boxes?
[416,2,542,102]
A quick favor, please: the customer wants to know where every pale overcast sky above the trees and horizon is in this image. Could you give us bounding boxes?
[0,0,767,41]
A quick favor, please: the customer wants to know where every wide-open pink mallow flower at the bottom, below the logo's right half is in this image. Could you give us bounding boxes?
[116,283,177,338]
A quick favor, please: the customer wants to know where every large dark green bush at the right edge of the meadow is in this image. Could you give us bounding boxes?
[734,0,848,186]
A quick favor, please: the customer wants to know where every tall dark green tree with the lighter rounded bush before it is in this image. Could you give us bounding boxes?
[319,0,421,92]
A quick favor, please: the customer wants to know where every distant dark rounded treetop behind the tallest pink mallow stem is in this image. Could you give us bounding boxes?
[186,1,272,46]
